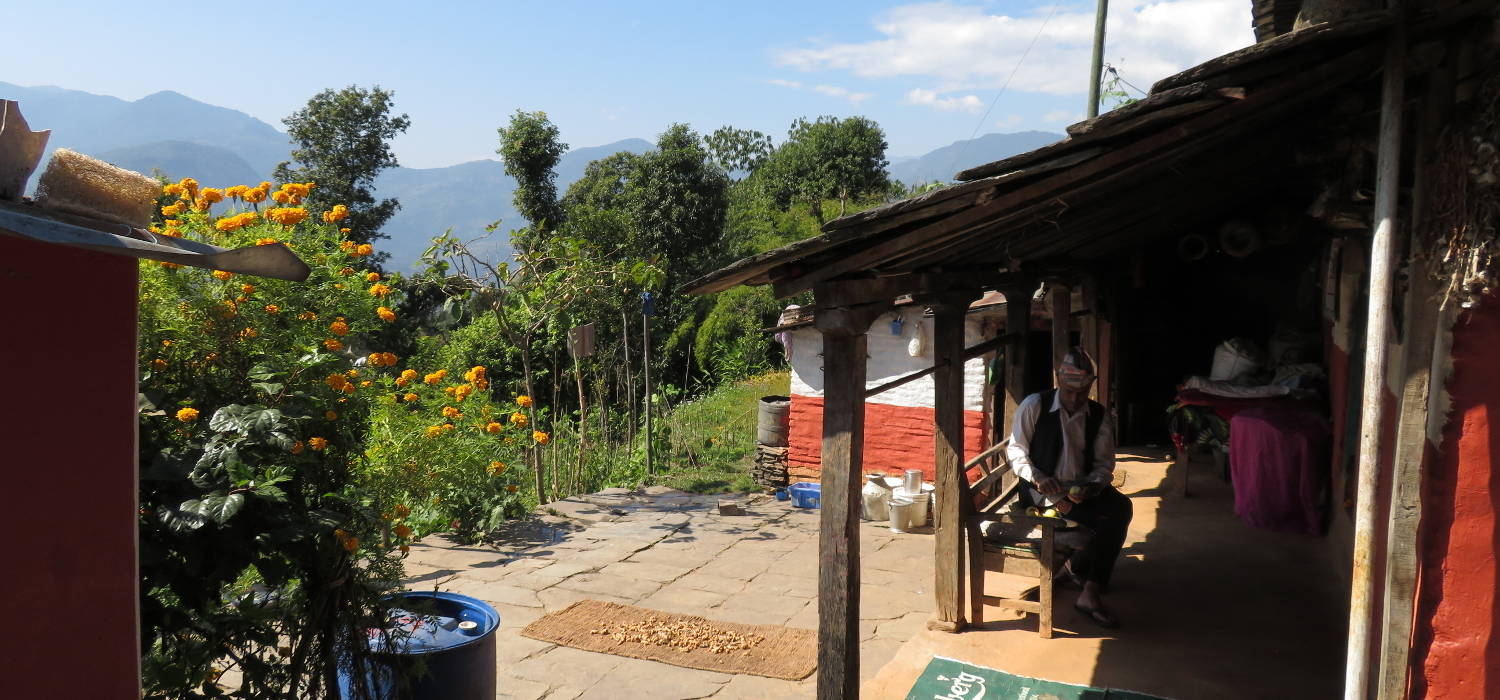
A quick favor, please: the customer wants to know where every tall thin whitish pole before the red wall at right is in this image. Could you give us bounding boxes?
[1344,17,1407,700]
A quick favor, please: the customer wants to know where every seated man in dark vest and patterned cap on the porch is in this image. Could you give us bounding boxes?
[1007,348,1131,628]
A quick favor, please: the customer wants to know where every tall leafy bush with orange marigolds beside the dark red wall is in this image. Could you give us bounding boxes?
[138,184,401,699]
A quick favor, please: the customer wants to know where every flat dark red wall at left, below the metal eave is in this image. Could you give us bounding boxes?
[0,234,141,699]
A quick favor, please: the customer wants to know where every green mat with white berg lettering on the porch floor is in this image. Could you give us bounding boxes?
[906,657,1166,700]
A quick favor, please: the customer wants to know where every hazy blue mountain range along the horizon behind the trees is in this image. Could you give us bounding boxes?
[0,82,1062,271]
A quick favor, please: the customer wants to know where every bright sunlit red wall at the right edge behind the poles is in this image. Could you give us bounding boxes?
[1410,298,1500,700]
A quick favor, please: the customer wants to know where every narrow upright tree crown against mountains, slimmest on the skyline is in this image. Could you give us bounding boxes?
[495,109,567,246]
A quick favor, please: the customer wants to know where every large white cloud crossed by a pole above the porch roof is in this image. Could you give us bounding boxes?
[773,0,1254,97]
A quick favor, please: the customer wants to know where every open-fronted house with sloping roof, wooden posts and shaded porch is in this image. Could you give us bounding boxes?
[690,0,1500,700]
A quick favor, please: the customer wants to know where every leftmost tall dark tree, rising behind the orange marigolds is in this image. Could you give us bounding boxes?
[276,85,411,243]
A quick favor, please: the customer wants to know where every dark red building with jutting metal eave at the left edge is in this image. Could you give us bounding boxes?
[0,100,309,699]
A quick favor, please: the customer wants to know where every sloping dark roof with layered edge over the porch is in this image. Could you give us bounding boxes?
[684,10,1416,297]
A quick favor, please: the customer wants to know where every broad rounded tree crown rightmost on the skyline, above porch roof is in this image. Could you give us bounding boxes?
[758,117,888,222]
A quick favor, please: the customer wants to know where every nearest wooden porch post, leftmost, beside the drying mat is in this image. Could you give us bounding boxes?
[815,290,890,700]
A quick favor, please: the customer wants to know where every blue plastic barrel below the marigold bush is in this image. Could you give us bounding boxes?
[339,591,500,700]
